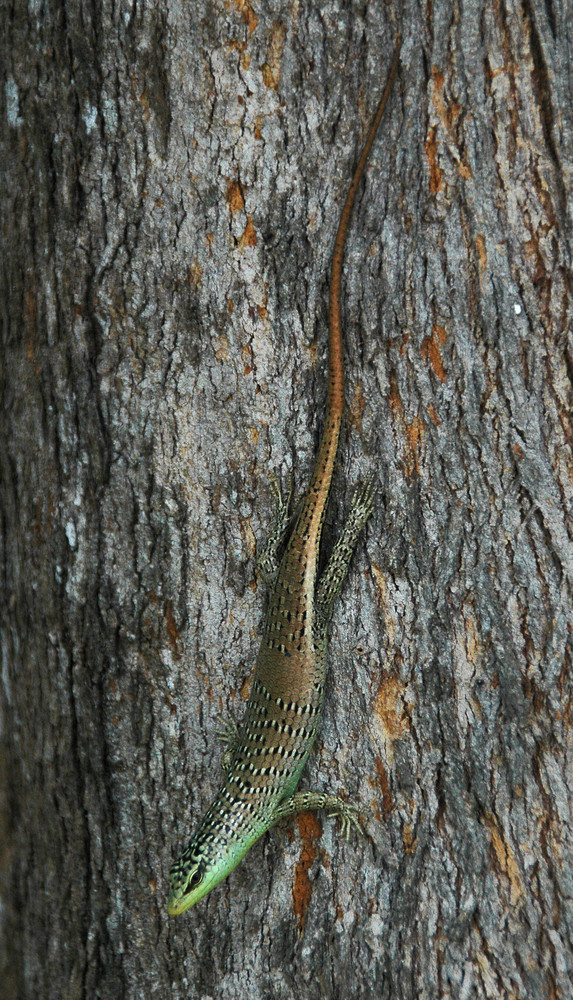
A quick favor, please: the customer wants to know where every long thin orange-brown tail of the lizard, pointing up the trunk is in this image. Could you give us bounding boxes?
[301,36,402,539]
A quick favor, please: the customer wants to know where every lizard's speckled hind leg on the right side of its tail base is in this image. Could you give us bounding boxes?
[316,477,376,625]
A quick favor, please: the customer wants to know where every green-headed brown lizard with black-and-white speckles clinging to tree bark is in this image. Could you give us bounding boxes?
[167,38,401,916]
